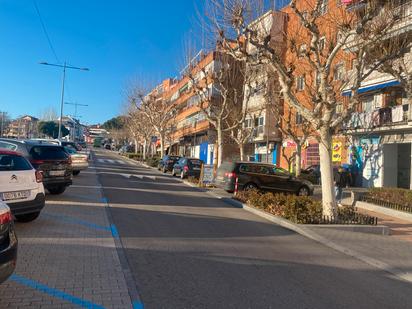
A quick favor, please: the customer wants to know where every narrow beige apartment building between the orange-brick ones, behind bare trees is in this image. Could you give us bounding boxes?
[243,10,287,164]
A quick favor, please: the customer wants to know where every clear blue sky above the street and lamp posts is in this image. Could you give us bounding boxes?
[0,0,286,124]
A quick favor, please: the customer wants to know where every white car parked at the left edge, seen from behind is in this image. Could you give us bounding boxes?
[0,149,45,222]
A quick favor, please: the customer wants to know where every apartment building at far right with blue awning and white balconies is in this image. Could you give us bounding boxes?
[343,0,412,189]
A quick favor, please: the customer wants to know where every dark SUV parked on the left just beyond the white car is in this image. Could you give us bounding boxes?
[0,138,73,194]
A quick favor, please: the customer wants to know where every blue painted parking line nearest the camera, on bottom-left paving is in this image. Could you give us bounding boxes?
[10,274,105,309]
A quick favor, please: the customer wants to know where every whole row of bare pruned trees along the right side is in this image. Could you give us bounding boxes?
[118,0,412,216]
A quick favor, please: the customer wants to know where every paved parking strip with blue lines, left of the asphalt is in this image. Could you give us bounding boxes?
[0,167,132,308]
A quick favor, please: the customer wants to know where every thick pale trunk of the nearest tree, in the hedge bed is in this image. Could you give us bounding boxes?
[319,128,337,217]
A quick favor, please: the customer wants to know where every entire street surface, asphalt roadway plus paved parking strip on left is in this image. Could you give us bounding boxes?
[0,151,412,308]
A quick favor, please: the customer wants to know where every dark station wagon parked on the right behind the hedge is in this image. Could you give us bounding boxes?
[215,162,314,195]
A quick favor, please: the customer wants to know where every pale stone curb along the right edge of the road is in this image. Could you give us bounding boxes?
[117,154,412,283]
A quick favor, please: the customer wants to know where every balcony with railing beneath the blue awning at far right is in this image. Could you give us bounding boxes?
[343,104,412,133]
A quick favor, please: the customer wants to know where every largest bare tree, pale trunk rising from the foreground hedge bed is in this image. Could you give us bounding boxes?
[209,0,404,216]
